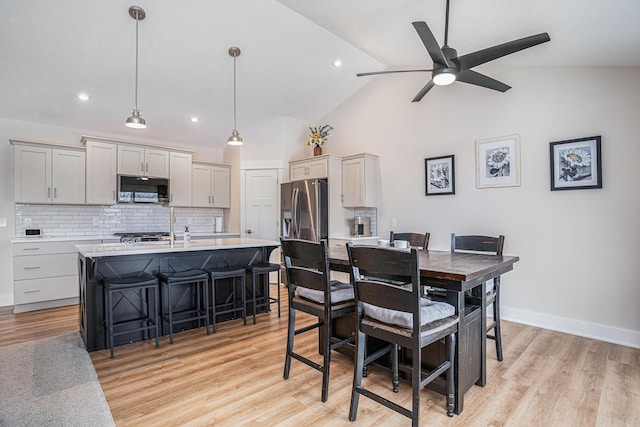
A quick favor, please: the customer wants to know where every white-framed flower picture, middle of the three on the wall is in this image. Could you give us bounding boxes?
[476,135,520,188]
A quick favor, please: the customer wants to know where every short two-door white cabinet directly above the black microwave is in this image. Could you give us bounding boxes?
[118,144,169,178]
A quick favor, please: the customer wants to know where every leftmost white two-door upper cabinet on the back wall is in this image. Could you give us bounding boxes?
[11,141,85,204]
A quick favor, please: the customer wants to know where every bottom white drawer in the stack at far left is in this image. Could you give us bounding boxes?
[13,275,79,305]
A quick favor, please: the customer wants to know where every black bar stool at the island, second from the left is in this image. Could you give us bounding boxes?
[158,270,209,344]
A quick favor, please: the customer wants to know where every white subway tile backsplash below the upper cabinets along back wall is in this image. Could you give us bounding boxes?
[15,204,226,237]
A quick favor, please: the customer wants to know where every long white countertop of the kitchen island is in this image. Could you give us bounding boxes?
[76,237,280,258]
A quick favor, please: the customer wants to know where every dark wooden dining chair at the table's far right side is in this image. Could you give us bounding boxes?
[451,233,504,362]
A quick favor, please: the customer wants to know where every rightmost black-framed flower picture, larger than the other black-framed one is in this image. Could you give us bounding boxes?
[550,136,602,191]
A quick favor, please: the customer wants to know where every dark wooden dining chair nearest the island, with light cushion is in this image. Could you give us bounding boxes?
[280,237,355,402]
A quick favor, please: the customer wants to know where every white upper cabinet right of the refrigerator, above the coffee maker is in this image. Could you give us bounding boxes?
[342,154,378,208]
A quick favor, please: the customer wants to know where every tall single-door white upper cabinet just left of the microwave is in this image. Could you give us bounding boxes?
[85,140,118,205]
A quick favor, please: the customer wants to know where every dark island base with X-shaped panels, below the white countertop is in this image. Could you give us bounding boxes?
[78,246,275,351]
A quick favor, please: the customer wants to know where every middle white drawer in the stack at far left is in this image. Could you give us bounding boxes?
[13,252,78,280]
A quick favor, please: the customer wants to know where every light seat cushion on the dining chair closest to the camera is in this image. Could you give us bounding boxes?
[363,298,456,329]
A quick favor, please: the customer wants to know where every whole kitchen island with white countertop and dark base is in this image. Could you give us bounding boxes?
[76,238,280,351]
